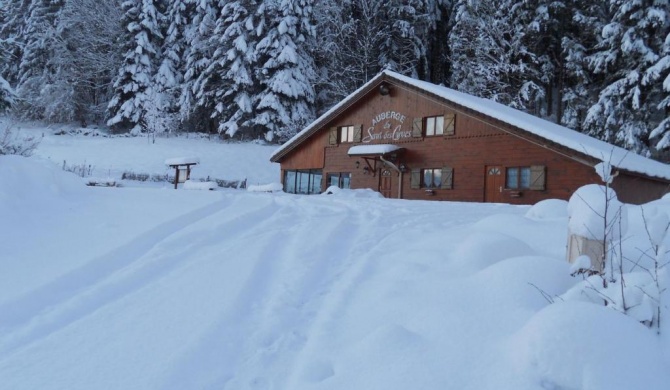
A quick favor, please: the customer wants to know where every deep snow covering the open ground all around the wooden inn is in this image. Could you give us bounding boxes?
[0,120,670,390]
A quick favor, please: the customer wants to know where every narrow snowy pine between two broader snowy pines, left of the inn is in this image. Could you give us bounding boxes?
[179,0,220,133]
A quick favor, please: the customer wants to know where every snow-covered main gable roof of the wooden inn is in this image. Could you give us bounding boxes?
[271,71,670,180]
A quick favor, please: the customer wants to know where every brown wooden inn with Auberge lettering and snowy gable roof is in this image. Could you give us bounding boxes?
[271,71,670,204]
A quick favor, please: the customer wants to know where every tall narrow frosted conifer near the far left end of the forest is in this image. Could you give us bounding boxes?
[16,0,64,119]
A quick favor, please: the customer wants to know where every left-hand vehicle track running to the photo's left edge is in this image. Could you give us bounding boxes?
[0,196,272,359]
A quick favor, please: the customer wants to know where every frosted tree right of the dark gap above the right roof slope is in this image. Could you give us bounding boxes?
[449,0,544,110]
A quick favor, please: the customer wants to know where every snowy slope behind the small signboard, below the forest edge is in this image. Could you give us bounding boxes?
[0,118,279,185]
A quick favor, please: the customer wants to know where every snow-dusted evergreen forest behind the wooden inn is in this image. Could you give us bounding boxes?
[0,0,670,160]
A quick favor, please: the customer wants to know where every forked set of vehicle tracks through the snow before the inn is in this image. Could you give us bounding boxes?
[0,194,510,389]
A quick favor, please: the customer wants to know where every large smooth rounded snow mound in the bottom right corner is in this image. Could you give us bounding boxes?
[507,302,670,390]
